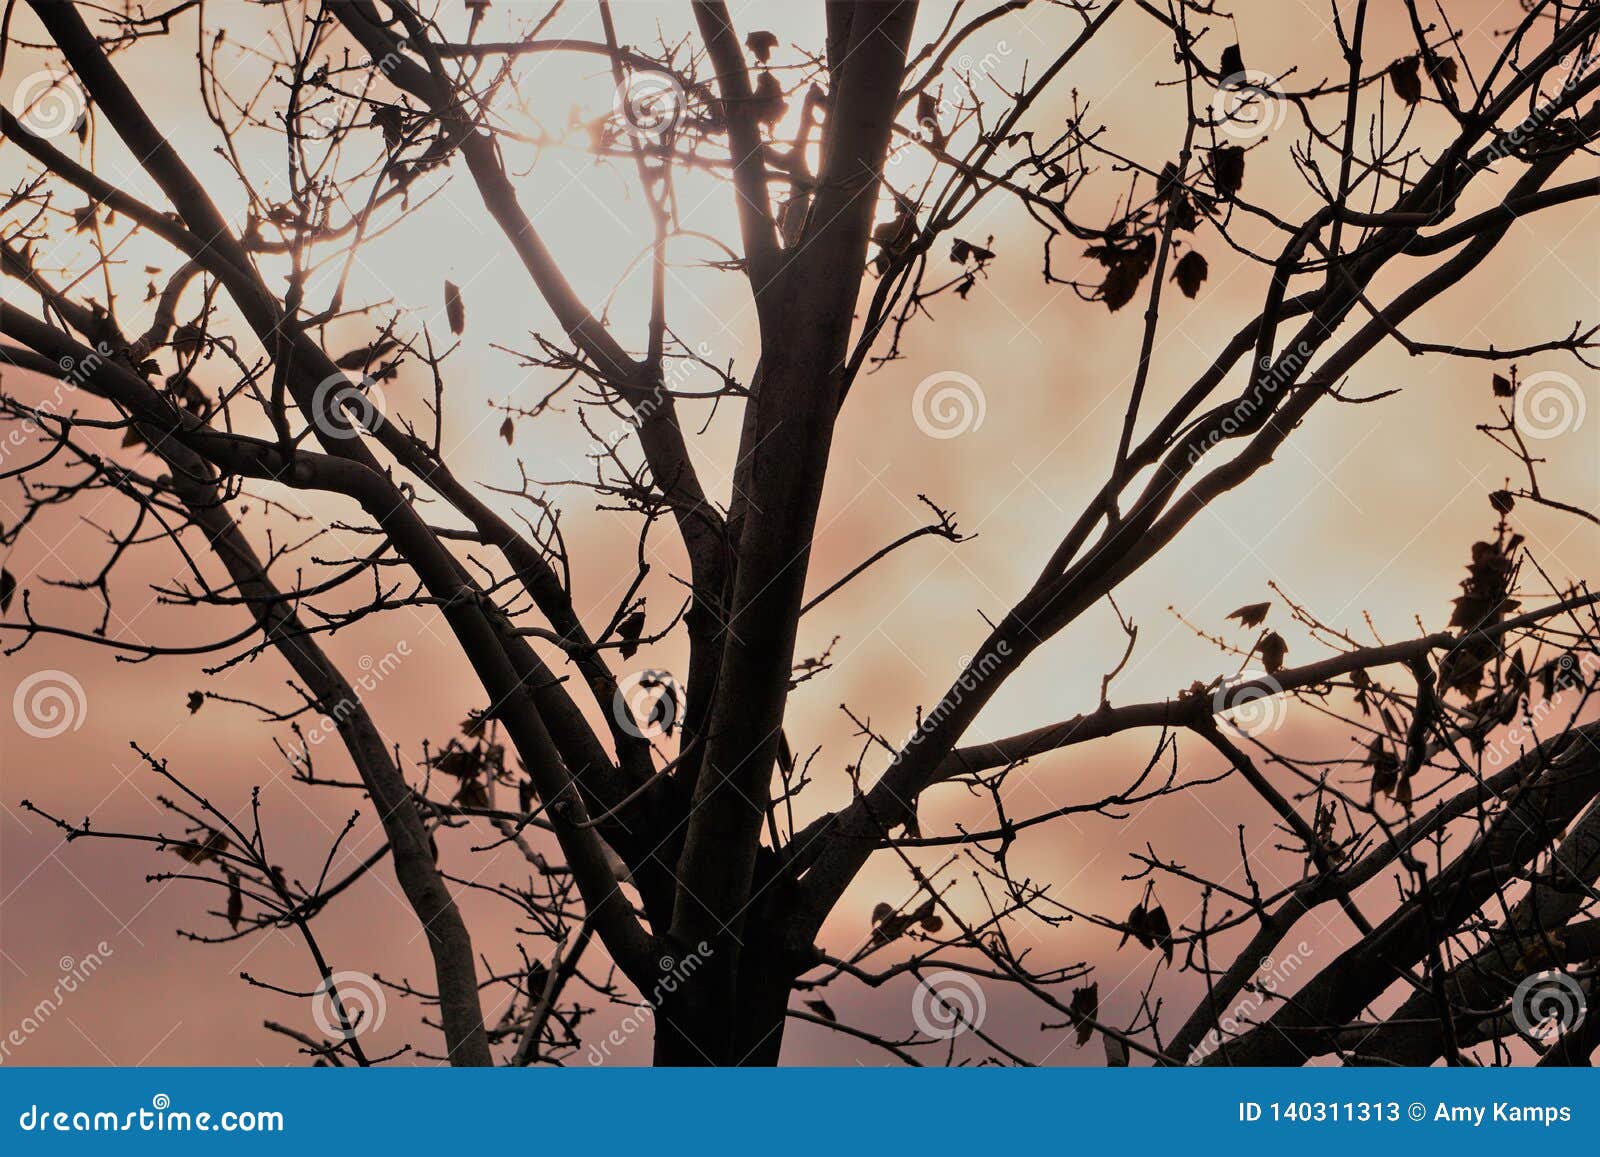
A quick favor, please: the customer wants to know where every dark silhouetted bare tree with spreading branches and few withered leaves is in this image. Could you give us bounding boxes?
[0,0,1600,1064]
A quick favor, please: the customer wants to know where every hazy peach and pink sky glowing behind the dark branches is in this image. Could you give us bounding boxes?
[0,0,1600,1064]
